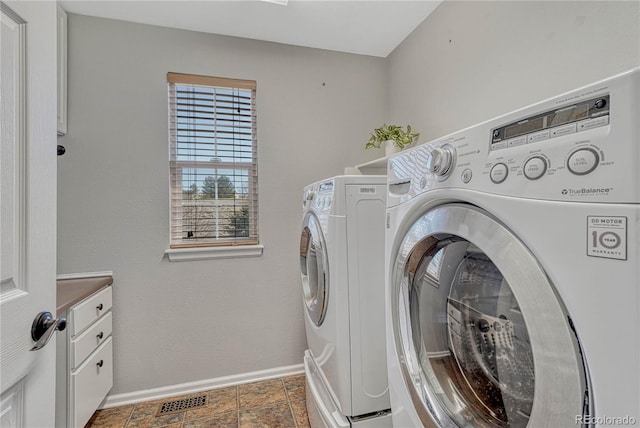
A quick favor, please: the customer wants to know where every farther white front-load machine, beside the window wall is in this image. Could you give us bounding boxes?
[300,175,391,428]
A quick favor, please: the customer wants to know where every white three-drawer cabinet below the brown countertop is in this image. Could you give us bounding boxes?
[56,286,113,428]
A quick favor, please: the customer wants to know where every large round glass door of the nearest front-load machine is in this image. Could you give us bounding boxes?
[391,204,589,427]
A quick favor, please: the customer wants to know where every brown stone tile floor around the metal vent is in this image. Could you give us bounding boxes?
[85,374,309,428]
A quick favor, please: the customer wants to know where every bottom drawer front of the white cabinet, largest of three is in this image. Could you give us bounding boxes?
[71,337,113,427]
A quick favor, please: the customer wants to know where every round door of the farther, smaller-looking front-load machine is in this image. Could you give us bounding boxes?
[300,213,329,326]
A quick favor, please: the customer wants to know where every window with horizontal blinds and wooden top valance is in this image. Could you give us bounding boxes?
[167,73,258,248]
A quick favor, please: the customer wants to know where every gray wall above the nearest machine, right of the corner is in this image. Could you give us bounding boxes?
[387,1,640,143]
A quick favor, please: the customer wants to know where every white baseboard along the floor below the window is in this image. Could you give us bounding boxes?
[100,364,304,409]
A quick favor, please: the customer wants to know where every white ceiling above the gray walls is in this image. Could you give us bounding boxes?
[60,0,442,57]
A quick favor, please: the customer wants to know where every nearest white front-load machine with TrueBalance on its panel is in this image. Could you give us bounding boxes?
[385,69,640,428]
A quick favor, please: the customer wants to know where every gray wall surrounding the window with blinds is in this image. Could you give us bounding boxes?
[58,15,388,394]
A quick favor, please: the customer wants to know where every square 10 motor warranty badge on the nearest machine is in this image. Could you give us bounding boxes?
[587,216,627,260]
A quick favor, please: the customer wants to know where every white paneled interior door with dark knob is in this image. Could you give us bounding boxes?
[0,1,56,427]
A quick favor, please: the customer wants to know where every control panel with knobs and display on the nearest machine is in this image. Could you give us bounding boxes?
[387,69,640,203]
